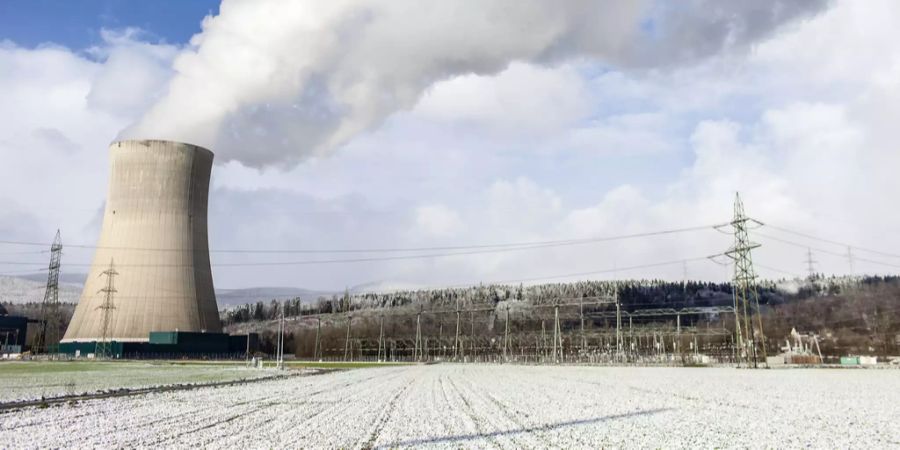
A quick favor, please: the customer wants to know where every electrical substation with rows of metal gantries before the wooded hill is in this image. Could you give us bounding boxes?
[274,299,753,365]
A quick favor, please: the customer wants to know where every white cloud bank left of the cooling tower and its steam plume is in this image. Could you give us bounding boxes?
[0,31,175,256]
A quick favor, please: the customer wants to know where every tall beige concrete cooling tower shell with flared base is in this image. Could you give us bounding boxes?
[62,140,222,342]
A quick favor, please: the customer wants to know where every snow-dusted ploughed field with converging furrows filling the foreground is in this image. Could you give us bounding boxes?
[0,364,900,448]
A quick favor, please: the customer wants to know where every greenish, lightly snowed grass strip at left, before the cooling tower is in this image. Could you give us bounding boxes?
[0,361,271,402]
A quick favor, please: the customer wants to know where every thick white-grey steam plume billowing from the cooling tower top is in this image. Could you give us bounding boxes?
[120,0,825,167]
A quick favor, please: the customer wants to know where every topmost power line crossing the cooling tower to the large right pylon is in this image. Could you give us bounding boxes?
[0,224,721,254]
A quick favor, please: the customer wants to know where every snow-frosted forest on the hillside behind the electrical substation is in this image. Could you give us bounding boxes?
[222,276,900,358]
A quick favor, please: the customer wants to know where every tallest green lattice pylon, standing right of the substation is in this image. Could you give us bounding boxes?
[725,193,767,368]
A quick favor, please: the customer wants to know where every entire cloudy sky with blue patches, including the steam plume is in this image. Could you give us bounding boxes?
[0,0,900,290]
